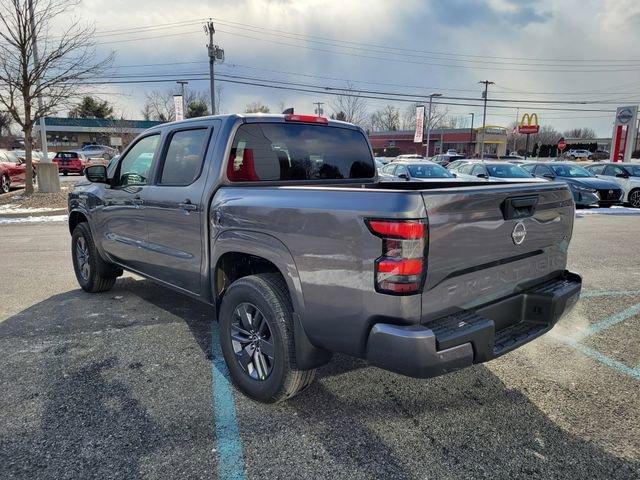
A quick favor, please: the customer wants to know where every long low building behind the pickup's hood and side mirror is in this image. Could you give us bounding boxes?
[33,117,162,152]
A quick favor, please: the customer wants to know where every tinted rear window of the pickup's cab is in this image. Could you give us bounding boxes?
[227,123,376,182]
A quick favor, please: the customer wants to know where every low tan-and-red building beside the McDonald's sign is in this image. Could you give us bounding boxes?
[369,125,507,157]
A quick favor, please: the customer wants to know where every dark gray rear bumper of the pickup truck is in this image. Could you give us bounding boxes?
[367,271,582,378]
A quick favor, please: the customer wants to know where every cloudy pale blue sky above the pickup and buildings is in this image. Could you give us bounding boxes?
[52,0,640,136]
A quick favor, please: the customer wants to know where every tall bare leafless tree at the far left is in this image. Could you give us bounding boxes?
[0,0,112,195]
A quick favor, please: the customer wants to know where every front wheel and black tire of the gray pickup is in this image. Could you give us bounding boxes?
[71,222,122,293]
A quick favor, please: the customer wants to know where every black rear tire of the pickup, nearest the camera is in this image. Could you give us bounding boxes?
[218,274,315,403]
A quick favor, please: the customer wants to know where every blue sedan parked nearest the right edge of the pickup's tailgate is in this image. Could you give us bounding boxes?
[523,162,623,207]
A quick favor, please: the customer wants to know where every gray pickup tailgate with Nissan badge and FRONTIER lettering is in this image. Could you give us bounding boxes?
[422,182,574,321]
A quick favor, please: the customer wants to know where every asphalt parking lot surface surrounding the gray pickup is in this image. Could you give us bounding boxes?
[0,215,640,479]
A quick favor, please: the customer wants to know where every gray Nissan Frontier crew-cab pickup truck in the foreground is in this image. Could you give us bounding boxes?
[69,114,581,402]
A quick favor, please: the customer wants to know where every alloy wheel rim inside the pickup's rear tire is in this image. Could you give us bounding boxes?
[231,303,275,380]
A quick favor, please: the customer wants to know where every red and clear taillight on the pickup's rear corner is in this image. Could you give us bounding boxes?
[366,219,428,295]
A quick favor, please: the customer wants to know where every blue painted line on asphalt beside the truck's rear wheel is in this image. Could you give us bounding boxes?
[211,320,246,480]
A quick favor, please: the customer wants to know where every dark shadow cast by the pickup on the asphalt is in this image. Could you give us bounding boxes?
[0,279,640,479]
